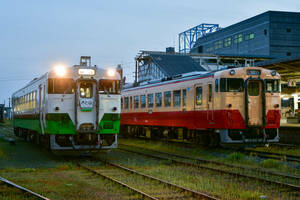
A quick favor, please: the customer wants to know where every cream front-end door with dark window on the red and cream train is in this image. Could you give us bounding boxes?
[246,80,263,126]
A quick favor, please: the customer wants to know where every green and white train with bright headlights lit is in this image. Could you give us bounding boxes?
[12,56,121,151]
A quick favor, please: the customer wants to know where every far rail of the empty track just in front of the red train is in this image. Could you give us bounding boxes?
[119,144,300,180]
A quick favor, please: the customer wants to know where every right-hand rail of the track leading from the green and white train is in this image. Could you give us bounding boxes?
[96,158,218,200]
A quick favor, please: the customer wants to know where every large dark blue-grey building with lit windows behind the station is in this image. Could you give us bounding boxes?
[189,11,300,58]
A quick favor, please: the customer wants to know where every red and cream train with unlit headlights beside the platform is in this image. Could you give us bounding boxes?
[121,67,280,145]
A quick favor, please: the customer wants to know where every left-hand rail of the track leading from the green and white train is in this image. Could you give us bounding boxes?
[77,162,158,200]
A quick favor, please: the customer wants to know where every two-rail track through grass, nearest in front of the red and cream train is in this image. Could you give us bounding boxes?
[119,144,300,191]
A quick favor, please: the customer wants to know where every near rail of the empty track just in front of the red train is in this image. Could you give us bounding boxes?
[118,147,300,191]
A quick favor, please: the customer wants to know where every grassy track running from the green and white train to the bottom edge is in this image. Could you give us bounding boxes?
[78,158,217,200]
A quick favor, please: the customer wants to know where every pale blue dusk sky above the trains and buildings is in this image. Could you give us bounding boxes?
[0,0,300,105]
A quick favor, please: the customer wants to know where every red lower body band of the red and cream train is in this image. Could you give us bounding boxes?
[121,110,280,129]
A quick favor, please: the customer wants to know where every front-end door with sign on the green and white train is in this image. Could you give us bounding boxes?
[75,80,98,132]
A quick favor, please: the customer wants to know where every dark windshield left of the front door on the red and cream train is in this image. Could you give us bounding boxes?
[220,78,244,92]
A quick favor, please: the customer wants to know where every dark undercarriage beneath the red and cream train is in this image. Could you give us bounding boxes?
[121,125,279,147]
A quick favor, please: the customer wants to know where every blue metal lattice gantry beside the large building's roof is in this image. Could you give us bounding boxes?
[179,23,220,53]
